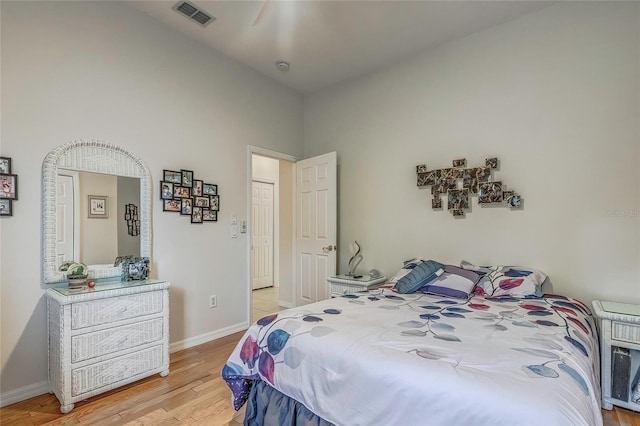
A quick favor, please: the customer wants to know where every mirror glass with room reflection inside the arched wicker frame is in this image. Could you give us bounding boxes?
[56,169,140,267]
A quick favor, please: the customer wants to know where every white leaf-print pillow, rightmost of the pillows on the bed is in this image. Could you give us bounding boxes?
[460,261,547,297]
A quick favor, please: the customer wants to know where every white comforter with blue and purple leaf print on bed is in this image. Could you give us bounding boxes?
[222,290,602,425]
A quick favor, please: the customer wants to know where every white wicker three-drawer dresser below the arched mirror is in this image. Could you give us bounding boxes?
[46,280,169,413]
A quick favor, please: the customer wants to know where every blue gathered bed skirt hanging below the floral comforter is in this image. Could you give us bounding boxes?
[244,380,333,426]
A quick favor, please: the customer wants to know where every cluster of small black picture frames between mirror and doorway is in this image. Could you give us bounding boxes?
[160,169,220,223]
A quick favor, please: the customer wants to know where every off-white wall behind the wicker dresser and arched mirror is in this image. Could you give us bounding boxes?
[0,1,303,403]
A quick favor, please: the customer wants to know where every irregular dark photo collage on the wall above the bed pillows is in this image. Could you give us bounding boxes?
[416,157,522,217]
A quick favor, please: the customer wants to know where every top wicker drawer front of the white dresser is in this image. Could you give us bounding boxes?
[71,291,163,330]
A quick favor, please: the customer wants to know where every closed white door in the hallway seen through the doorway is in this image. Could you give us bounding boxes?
[251,181,273,290]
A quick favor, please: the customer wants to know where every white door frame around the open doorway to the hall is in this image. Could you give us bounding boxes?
[245,145,301,324]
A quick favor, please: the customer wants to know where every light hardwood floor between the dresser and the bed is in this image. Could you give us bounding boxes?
[0,300,640,426]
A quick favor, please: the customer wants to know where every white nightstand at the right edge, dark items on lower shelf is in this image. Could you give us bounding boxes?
[593,300,640,411]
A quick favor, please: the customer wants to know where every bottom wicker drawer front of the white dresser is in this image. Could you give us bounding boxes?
[71,345,163,396]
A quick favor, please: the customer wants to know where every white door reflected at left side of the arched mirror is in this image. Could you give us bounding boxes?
[56,174,79,266]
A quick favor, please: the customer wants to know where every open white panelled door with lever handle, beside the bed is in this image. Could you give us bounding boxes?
[296,152,337,306]
